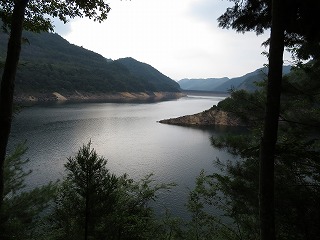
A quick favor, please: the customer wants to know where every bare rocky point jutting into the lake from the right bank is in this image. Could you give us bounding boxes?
[159,106,244,126]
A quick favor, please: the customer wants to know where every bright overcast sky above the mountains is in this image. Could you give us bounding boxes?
[55,0,290,80]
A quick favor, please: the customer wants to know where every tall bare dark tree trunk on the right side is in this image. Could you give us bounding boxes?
[259,0,284,240]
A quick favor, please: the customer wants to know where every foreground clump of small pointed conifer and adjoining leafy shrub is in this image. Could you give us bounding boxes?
[50,142,178,239]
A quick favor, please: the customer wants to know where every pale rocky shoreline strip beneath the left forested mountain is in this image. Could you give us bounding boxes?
[14,91,186,103]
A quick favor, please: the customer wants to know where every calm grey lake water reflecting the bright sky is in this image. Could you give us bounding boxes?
[9,96,238,216]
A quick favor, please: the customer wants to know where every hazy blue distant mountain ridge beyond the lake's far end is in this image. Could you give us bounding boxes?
[178,66,291,92]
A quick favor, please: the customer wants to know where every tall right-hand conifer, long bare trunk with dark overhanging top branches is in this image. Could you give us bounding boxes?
[218,0,320,240]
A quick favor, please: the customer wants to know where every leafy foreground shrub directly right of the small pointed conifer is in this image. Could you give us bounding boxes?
[106,174,172,239]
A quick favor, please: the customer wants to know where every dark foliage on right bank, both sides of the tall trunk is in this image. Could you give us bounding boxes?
[188,63,320,240]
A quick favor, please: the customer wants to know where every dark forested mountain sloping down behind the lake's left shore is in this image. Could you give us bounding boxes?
[0,32,180,97]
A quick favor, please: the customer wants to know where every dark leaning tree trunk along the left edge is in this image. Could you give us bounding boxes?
[0,0,28,208]
